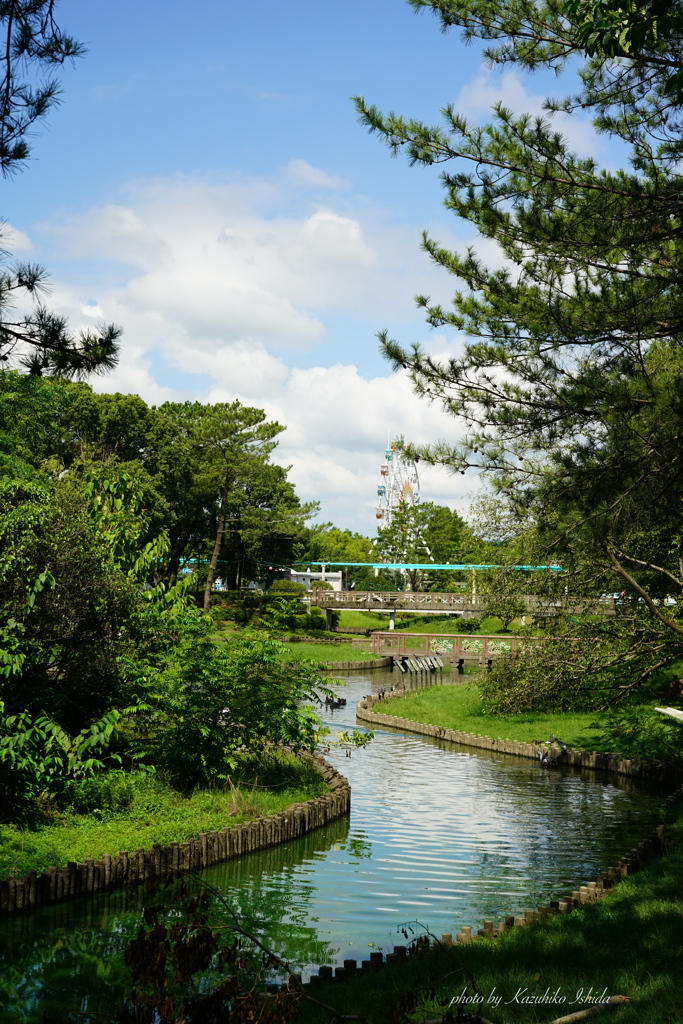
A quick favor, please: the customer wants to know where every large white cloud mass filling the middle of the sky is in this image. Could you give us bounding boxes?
[30,161,471,534]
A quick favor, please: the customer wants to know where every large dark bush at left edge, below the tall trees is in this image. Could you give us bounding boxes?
[0,481,172,732]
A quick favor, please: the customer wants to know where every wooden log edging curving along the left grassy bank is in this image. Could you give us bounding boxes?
[0,757,351,915]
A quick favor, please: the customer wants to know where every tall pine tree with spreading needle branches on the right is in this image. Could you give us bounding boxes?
[356,0,683,689]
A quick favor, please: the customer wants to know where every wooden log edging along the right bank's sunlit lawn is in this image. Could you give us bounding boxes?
[355,688,679,785]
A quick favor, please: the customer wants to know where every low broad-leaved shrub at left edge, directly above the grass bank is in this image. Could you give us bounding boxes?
[0,700,120,820]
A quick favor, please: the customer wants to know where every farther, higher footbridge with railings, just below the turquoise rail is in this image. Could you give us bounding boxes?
[310,589,614,630]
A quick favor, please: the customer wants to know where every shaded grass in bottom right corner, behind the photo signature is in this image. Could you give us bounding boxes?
[299,812,683,1024]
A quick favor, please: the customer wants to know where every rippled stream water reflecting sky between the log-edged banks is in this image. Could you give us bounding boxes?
[0,671,659,1024]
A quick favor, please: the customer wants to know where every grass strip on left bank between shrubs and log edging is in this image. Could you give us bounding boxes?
[0,759,327,878]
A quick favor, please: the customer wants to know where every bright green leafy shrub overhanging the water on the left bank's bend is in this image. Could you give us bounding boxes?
[129,608,333,791]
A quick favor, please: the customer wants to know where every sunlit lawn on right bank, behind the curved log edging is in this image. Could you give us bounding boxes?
[382,684,600,750]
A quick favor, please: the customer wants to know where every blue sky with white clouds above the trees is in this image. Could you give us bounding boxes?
[0,0,603,535]
